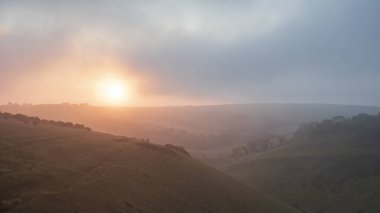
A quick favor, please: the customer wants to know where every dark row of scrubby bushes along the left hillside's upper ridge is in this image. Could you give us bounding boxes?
[0,111,91,131]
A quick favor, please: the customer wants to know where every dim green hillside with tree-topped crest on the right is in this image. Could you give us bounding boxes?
[227,114,380,213]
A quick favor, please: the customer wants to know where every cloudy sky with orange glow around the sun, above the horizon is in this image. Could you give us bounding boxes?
[0,0,380,106]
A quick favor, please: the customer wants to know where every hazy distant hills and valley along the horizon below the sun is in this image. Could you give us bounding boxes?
[0,103,380,150]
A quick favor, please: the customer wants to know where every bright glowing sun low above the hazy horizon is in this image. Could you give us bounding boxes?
[99,78,130,105]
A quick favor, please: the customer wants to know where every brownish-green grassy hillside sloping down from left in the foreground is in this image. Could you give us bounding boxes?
[0,115,295,212]
